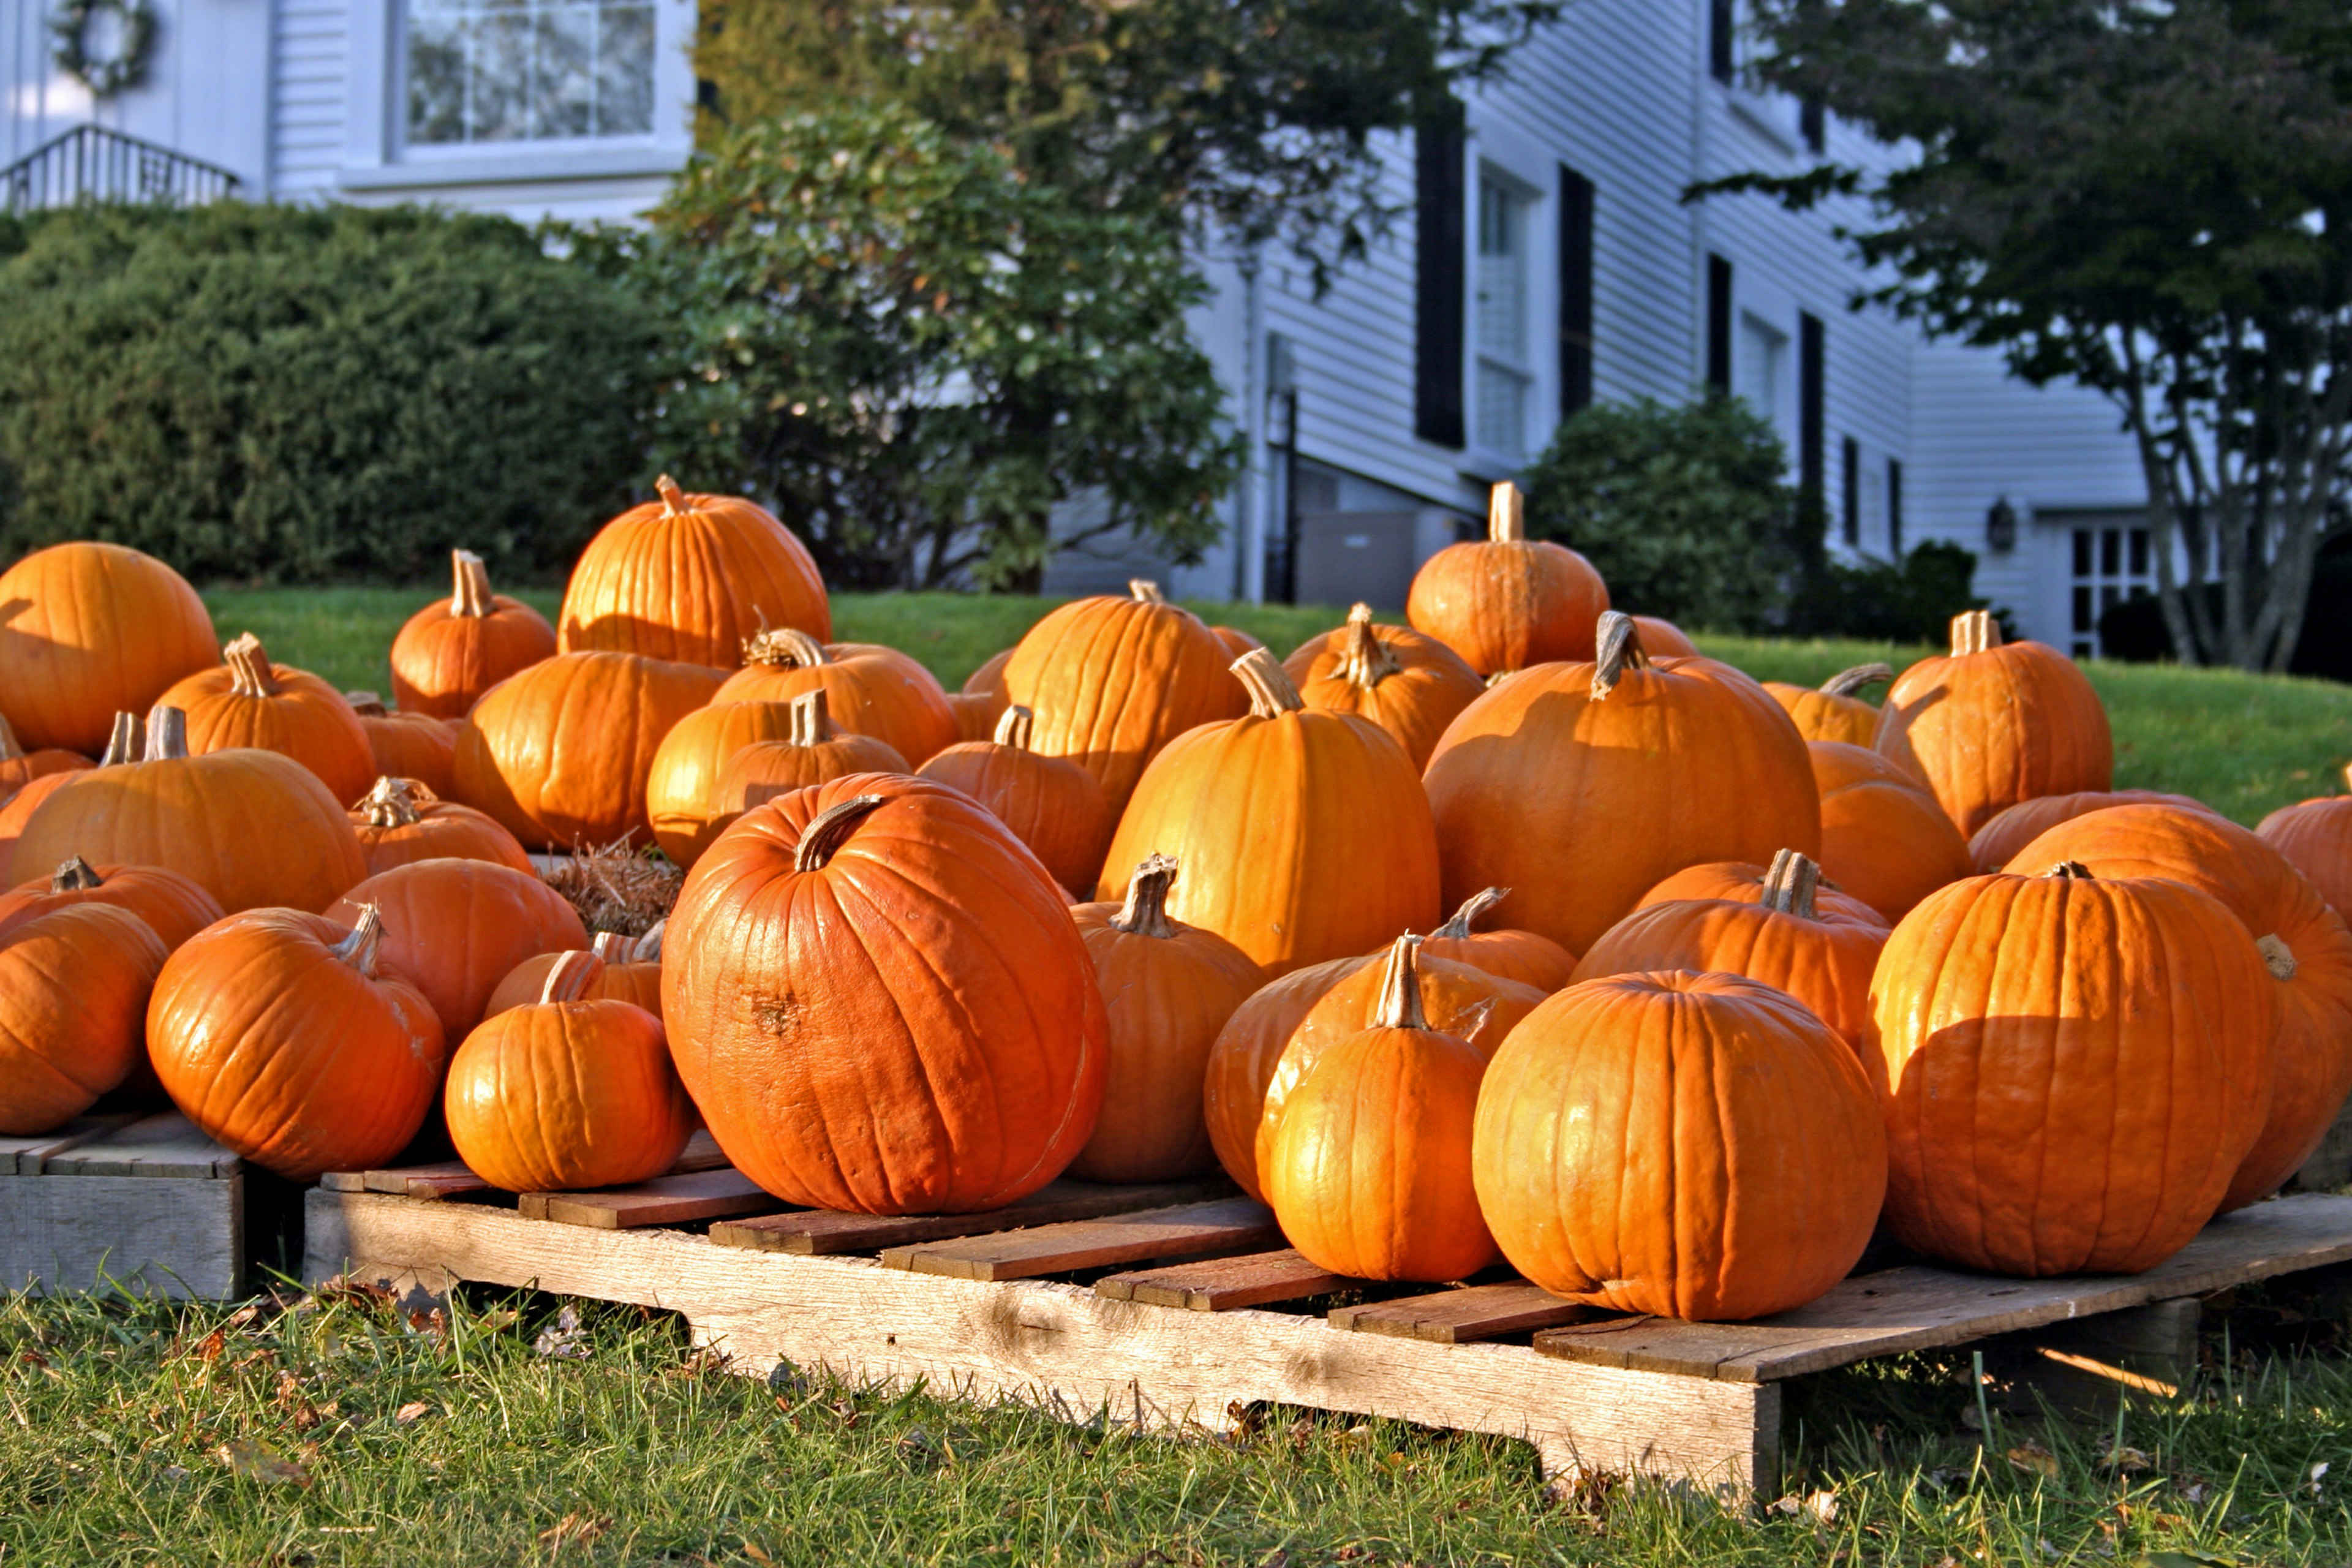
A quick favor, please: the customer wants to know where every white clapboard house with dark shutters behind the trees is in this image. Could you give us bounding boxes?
[0,0,2152,654]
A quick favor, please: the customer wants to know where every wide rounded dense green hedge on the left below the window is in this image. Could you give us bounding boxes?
[0,202,654,581]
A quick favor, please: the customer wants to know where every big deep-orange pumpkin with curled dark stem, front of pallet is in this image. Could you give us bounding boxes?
[661,774,1108,1213]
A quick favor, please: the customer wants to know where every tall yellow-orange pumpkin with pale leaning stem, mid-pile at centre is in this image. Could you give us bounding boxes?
[1096,649,1437,973]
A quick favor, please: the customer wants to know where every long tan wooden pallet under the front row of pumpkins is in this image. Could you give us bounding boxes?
[306,1147,2352,1495]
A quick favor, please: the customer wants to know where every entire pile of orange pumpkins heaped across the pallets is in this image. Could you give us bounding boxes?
[0,480,2352,1319]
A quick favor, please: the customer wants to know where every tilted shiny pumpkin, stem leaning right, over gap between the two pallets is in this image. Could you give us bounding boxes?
[146,907,449,1183]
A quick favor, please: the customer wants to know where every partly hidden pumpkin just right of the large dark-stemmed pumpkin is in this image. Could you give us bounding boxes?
[1806,741,1976,924]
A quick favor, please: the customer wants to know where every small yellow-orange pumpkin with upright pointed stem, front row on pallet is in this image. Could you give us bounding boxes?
[1263,936,1496,1284]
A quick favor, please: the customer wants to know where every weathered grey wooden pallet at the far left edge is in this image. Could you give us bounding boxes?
[0,1112,244,1300]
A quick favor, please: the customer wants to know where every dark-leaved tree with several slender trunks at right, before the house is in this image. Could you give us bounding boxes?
[1694,0,2352,670]
